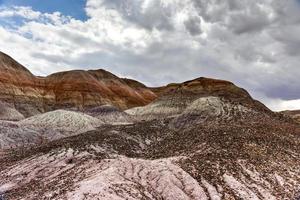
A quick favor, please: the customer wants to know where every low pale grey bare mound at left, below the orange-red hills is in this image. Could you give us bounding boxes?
[0,110,103,149]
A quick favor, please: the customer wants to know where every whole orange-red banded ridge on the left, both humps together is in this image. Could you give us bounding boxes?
[0,52,156,117]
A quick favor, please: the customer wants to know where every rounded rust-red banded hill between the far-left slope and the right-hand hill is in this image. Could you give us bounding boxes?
[45,70,156,109]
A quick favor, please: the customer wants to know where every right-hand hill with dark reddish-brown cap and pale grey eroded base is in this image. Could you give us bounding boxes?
[126,78,272,118]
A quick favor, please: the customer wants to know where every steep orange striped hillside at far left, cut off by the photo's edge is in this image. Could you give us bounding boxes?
[0,53,44,116]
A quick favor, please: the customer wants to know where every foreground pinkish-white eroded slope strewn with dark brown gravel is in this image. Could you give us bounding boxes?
[0,115,300,199]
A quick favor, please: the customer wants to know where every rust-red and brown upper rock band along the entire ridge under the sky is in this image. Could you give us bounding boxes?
[0,53,269,117]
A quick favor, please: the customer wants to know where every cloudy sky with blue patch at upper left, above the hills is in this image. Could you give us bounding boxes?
[0,0,300,111]
